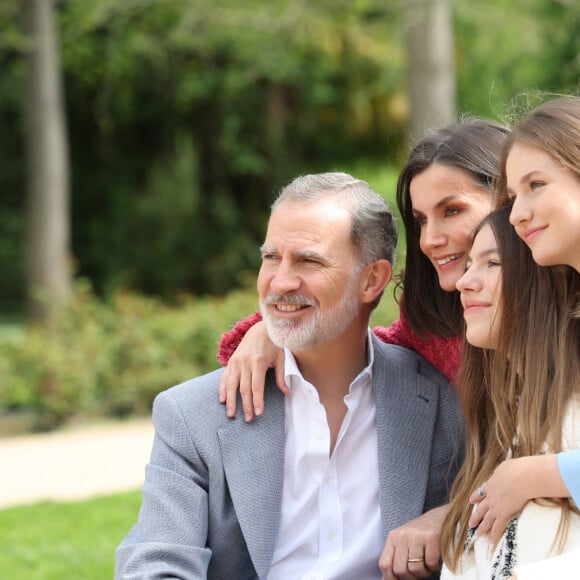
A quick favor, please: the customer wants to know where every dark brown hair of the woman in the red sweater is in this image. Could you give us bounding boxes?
[397,118,509,337]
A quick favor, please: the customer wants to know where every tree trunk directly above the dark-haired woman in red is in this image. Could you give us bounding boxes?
[406,0,456,143]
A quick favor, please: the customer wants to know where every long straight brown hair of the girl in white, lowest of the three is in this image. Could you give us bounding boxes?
[441,206,580,570]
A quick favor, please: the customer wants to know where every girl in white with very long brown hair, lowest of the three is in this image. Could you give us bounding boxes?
[442,206,580,580]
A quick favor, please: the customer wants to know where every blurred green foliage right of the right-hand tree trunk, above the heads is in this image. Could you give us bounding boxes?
[455,0,580,123]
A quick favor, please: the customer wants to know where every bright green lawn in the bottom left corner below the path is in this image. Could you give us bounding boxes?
[0,492,141,580]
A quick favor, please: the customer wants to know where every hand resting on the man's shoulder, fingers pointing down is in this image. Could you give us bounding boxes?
[219,322,289,421]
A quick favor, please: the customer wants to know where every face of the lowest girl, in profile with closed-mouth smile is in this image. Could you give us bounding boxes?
[457,225,501,349]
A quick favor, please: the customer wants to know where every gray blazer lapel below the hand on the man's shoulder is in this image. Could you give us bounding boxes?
[218,381,285,578]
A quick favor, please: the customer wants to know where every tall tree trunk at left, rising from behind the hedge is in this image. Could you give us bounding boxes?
[24,0,72,322]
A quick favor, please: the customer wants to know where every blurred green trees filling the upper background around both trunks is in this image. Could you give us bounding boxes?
[0,0,580,314]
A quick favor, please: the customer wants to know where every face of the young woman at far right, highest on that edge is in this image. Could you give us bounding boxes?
[506,142,580,271]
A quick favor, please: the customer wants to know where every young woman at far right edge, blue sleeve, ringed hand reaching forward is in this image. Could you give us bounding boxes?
[458,96,580,578]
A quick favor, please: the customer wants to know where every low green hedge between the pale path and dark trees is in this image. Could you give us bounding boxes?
[0,287,256,428]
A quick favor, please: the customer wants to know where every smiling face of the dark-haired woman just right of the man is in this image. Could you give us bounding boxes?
[409,163,493,292]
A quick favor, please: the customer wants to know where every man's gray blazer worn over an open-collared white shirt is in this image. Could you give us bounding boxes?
[115,337,464,580]
